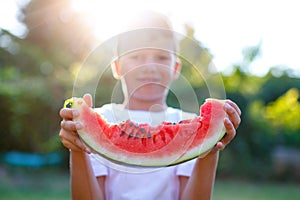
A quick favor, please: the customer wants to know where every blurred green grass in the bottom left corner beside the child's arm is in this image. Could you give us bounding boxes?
[0,167,71,200]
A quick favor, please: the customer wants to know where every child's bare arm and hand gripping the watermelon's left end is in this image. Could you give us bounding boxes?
[59,96,105,199]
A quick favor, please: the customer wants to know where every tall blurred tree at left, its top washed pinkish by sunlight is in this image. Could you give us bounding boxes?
[0,0,102,152]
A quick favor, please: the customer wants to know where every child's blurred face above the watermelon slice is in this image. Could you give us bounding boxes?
[118,49,180,101]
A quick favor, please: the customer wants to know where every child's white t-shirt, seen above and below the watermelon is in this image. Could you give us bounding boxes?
[90,104,195,200]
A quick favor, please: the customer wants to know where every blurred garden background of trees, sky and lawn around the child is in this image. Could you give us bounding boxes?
[0,0,300,199]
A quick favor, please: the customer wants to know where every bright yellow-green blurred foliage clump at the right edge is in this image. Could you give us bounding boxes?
[252,88,300,147]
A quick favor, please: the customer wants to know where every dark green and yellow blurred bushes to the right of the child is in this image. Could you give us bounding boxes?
[219,44,300,179]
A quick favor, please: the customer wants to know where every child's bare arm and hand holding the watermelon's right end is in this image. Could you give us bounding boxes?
[179,100,241,200]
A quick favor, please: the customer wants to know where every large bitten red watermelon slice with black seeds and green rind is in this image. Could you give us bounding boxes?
[65,97,226,167]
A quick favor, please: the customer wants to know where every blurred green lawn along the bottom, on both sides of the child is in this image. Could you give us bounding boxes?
[0,166,300,200]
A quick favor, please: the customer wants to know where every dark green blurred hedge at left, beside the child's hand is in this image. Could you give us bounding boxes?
[0,67,59,152]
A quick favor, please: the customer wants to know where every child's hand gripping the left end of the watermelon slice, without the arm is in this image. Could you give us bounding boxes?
[59,94,92,153]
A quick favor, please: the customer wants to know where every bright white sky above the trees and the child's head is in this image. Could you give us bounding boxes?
[0,0,300,76]
